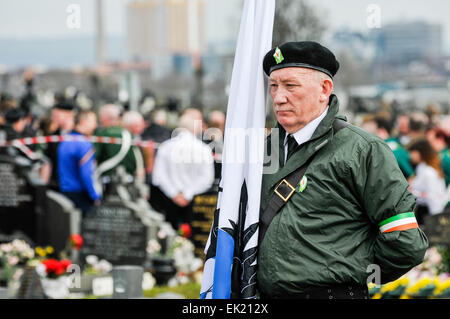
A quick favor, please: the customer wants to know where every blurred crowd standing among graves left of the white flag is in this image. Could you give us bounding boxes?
[0,79,225,234]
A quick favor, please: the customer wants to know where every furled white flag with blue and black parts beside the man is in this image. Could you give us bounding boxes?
[200,0,275,299]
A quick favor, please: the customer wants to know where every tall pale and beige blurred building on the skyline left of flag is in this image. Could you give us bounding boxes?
[126,0,206,77]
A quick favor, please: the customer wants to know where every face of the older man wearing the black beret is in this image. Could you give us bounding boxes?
[269,67,331,133]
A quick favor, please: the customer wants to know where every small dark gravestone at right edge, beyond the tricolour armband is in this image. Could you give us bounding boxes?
[424,212,450,248]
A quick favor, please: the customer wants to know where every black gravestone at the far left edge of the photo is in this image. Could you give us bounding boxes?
[0,154,45,243]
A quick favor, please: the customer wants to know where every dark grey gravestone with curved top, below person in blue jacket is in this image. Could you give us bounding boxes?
[81,203,148,265]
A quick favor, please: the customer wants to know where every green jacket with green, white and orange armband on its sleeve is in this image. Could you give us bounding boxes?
[257,95,428,298]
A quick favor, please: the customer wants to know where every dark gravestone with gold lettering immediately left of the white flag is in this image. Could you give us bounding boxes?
[190,191,218,259]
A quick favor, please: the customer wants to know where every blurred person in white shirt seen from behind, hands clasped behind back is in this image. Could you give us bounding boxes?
[150,109,214,229]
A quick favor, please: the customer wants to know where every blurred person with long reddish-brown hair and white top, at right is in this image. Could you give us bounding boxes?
[408,138,447,223]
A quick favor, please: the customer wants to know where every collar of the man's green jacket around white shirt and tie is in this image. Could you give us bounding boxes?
[264,94,339,188]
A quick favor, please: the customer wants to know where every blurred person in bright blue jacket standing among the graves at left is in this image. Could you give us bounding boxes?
[58,111,101,217]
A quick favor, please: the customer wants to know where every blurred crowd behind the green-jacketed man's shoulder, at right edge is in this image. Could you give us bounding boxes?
[361,111,450,225]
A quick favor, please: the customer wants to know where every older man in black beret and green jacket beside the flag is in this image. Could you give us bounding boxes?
[257,41,428,299]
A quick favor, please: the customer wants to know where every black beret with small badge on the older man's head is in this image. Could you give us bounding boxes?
[263,41,339,78]
